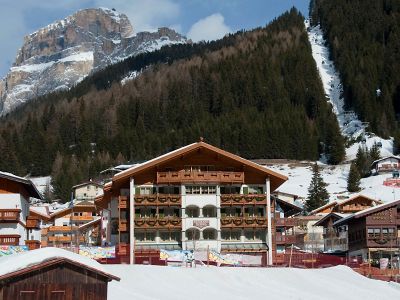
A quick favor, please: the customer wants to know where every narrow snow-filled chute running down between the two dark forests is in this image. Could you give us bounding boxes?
[305,20,393,160]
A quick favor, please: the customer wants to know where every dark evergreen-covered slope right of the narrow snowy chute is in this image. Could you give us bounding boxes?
[311,0,400,138]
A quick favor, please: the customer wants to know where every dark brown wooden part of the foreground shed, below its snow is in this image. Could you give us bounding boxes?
[0,250,120,300]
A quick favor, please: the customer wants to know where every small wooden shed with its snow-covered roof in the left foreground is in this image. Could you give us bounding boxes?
[0,248,120,300]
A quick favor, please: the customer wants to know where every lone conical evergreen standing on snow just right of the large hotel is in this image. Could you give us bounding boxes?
[305,163,329,212]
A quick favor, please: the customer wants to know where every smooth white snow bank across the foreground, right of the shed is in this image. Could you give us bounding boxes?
[104,265,400,300]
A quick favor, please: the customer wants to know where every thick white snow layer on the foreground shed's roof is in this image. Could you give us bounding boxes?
[0,247,109,276]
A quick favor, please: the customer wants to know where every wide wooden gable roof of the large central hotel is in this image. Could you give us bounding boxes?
[112,141,288,191]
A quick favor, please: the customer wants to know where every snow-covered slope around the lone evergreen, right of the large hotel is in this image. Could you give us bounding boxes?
[267,162,400,202]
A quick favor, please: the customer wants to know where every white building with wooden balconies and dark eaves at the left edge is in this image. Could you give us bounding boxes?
[0,172,42,247]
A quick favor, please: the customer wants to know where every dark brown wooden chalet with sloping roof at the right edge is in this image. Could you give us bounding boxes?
[333,200,400,261]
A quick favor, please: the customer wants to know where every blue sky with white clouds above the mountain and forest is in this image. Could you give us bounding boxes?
[0,0,309,77]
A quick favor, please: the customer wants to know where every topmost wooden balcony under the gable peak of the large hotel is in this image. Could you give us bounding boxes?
[157,170,244,184]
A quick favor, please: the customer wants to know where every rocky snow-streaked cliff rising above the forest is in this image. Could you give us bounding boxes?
[0,8,187,115]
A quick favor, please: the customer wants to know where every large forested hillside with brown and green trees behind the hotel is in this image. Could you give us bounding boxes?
[0,9,344,202]
